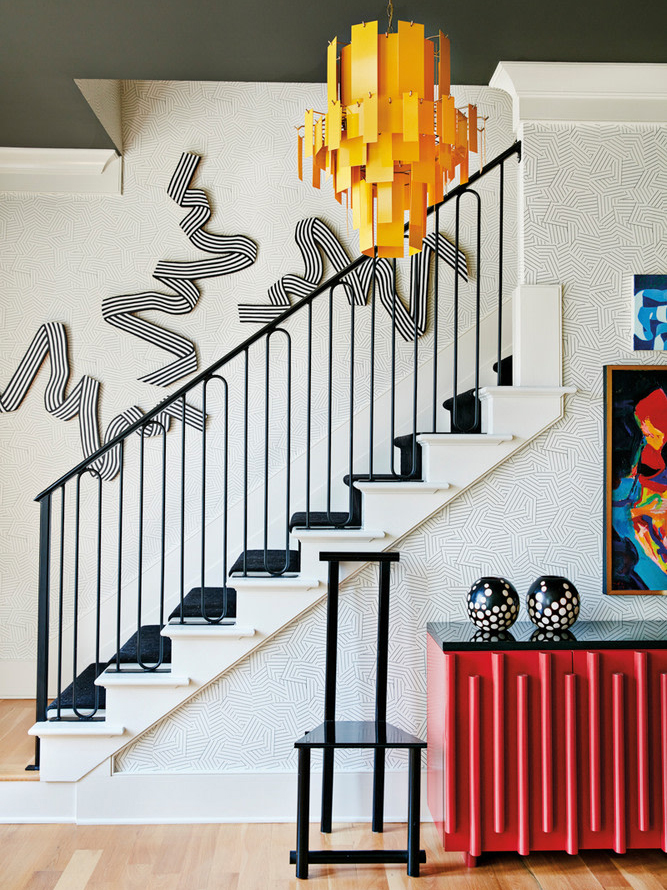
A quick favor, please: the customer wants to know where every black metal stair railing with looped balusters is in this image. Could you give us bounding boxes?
[30,143,521,765]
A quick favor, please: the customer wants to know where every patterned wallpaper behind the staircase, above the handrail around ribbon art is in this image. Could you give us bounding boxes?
[0,81,516,680]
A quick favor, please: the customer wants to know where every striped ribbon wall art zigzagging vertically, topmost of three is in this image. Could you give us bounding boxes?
[102,152,257,386]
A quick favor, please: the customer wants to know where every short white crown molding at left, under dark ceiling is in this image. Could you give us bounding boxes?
[0,147,123,195]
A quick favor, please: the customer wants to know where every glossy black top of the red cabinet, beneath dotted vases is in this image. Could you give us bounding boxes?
[427,620,667,652]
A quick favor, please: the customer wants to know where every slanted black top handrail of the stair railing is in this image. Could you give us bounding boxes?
[35,142,521,501]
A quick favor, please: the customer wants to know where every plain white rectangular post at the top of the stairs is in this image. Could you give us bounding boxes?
[512,284,563,386]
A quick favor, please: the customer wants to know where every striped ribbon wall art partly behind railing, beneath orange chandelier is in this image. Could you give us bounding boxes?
[239,218,468,340]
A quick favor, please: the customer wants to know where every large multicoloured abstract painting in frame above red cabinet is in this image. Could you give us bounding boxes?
[605,365,667,594]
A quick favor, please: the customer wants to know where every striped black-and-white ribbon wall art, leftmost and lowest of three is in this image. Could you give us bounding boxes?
[0,321,203,479]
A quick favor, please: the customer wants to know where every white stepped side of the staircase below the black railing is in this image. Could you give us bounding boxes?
[30,386,574,782]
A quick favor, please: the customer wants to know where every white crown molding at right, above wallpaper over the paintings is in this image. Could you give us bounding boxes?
[489,62,667,130]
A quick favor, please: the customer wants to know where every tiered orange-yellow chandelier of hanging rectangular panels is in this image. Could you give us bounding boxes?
[298,22,478,257]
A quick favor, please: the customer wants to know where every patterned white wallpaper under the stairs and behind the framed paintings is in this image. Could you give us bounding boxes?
[115,116,667,772]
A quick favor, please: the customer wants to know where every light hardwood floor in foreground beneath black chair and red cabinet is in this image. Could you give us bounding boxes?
[0,824,667,890]
